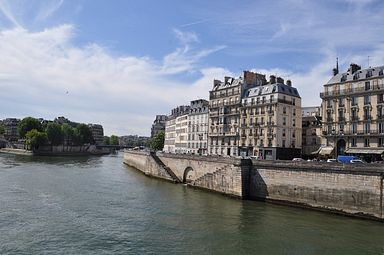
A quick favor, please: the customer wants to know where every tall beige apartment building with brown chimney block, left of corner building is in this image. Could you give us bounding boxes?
[208,71,266,156]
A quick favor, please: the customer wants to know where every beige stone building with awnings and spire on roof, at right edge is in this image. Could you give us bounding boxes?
[320,64,384,161]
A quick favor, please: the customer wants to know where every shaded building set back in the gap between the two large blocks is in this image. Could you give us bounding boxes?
[301,106,322,158]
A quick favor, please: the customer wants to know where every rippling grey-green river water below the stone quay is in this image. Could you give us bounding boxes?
[0,153,384,255]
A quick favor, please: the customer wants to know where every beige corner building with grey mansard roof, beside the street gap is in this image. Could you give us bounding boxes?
[239,75,302,160]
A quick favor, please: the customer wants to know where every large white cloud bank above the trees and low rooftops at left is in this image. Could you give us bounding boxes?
[0,25,228,135]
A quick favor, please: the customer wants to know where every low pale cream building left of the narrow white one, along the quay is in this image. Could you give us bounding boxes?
[163,105,190,153]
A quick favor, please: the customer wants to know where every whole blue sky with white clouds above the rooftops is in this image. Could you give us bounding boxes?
[0,0,384,135]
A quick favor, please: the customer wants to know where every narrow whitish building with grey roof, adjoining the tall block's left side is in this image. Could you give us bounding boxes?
[188,99,209,155]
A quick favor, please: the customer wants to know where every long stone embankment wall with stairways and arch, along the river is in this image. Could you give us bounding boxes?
[124,151,384,221]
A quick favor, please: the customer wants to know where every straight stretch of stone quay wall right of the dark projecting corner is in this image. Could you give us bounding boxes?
[249,163,383,219]
